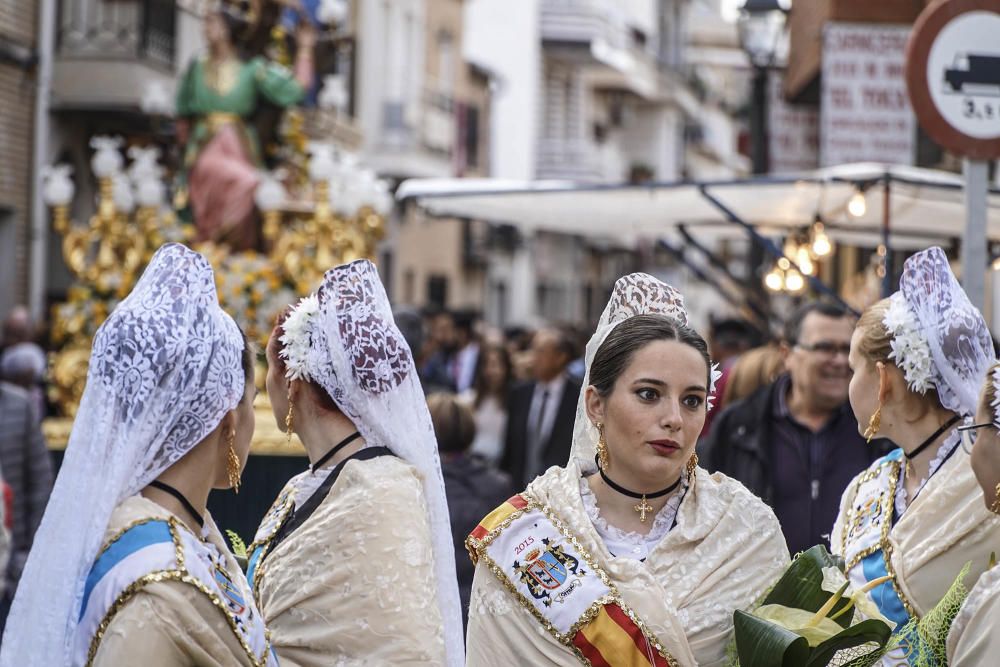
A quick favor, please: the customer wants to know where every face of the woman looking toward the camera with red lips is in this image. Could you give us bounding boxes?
[587,340,708,492]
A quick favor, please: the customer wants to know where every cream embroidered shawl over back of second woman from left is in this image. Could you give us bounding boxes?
[256,456,445,667]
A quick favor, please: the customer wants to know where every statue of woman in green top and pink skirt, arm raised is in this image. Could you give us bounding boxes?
[177,1,316,250]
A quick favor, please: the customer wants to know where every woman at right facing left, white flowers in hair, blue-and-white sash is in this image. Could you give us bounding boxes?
[831,247,1000,665]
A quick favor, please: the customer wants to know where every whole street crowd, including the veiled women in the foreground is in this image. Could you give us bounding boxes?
[0,244,1000,666]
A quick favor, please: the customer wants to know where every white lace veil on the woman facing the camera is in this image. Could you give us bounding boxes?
[570,273,696,467]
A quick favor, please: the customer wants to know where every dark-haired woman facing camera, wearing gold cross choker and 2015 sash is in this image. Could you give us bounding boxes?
[467,273,789,667]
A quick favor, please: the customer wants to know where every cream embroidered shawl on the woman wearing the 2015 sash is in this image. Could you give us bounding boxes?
[466,462,789,667]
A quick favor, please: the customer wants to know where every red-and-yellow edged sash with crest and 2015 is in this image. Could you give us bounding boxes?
[466,495,677,667]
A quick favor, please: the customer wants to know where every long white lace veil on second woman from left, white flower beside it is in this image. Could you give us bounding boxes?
[306,260,465,667]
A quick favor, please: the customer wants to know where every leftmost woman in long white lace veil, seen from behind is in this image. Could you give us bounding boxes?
[0,244,275,667]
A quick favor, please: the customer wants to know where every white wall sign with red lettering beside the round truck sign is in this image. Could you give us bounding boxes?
[820,23,916,167]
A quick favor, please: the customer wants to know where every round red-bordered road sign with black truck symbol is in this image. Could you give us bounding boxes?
[906,0,1000,160]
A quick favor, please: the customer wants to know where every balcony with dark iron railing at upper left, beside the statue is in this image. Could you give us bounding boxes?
[53,0,178,109]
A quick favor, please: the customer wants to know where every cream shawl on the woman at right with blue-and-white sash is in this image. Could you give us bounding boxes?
[831,451,1000,616]
